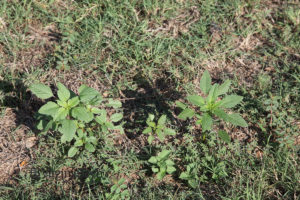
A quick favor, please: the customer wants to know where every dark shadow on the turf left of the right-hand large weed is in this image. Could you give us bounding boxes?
[122,72,182,139]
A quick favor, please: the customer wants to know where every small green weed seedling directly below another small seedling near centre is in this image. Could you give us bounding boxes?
[148,150,176,180]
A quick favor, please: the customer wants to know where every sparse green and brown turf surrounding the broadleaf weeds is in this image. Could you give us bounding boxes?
[0,0,300,200]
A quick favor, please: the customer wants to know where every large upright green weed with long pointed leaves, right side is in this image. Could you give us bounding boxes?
[176,70,248,142]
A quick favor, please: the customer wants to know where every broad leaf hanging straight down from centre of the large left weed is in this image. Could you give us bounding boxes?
[59,119,76,143]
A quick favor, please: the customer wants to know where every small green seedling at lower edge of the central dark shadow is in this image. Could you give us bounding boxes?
[143,114,176,144]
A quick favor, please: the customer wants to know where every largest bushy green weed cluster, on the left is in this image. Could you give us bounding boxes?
[30,83,123,157]
